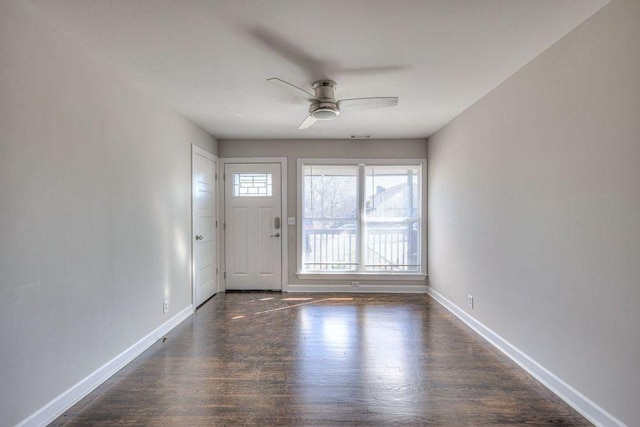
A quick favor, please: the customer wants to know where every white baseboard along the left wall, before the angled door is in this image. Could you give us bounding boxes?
[17,305,194,427]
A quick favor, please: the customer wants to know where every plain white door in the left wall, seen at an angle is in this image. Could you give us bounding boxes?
[191,146,218,307]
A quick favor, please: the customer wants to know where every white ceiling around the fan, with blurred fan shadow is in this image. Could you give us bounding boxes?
[23,0,609,139]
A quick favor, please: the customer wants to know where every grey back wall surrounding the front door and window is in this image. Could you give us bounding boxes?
[219,140,427,290]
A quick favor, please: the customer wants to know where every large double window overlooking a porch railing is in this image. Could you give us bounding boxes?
[298,160,423,274]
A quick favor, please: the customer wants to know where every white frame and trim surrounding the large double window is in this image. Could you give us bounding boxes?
[296,158,427,281]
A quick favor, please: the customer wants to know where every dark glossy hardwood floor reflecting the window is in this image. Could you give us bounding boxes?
[52,293,590,426]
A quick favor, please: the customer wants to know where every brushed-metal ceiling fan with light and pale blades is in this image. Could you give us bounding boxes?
[267,77,398,129]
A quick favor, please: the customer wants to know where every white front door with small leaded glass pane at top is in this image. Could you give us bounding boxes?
[224,163,283,290]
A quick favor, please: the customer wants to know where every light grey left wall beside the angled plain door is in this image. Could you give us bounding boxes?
[0,1,217,426]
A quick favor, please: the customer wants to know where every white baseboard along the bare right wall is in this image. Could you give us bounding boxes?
[427,287,625,427]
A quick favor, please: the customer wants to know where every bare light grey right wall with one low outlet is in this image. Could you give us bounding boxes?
[429,0,640,425]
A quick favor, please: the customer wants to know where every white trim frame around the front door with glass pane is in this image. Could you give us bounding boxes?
[218,157,289,292]
